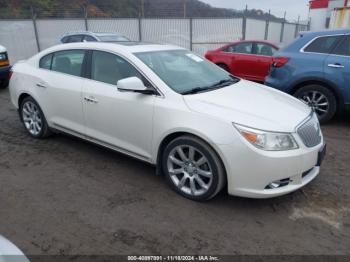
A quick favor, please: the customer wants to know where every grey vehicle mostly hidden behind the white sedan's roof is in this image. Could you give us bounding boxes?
[60,31,130,44]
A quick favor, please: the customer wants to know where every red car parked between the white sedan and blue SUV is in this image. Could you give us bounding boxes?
[205,41,279,82]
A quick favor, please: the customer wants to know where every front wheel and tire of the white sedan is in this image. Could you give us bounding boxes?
[162,136,225,201]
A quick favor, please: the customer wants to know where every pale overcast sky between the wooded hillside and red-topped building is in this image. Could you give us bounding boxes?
[201,0,309,21]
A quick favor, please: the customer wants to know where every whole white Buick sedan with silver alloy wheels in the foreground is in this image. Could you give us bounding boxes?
[10,42,325,200]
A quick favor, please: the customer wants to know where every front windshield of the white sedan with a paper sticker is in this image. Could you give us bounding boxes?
[135,50,239,94]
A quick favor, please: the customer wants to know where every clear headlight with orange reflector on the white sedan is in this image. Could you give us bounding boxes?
[234,124,299,151]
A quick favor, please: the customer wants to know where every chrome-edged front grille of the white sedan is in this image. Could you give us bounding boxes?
[297,114,322,147]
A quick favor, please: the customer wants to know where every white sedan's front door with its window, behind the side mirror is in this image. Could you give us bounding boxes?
[83,51,155,160]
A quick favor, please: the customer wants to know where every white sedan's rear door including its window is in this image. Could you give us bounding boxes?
[34,50,85,134]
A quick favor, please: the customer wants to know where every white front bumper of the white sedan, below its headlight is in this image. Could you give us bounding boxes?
[220,133,323,198]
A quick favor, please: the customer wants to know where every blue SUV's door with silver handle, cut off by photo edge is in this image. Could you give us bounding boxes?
[324,35,350,103]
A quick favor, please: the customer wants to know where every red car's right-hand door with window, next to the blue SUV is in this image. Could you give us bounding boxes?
[252,43,277,82]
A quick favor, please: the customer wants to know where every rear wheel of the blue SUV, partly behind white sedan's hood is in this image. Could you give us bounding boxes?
[294,85,337,124]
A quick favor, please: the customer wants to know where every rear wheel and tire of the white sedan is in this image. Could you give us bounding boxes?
[19,97,52,138]
